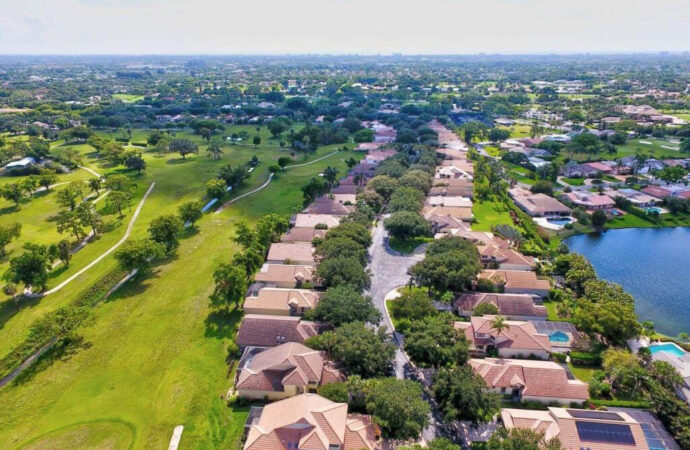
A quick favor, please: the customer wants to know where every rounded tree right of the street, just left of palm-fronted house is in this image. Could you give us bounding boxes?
[405,314,469,367]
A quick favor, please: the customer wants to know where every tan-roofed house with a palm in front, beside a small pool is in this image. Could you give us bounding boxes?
[455,315,551,359]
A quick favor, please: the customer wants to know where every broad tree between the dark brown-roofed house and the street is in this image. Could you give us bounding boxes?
[305,322,395,378]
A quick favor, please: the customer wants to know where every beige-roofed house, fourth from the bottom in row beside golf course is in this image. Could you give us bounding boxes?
[244,288,321,316]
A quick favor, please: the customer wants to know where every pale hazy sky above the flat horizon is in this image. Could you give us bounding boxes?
[0,0,690,55]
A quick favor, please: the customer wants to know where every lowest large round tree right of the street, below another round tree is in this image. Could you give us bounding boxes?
[431,366,501,425]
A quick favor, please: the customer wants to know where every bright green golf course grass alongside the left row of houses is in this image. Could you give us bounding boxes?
[0,125,361,449]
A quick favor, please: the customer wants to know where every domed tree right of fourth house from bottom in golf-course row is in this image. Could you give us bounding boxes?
[307,285,381,326]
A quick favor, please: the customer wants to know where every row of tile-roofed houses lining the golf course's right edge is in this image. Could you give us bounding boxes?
[235,142,392,450]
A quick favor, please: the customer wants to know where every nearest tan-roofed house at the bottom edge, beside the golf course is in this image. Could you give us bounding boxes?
[244,394,380,450]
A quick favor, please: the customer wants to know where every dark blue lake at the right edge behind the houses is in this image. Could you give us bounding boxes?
[565,228,690,336]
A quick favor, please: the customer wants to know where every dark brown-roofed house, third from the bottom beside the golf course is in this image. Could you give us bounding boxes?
[236,314,320,348]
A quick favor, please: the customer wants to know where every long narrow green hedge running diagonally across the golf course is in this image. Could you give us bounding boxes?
[0,269,126,378]
